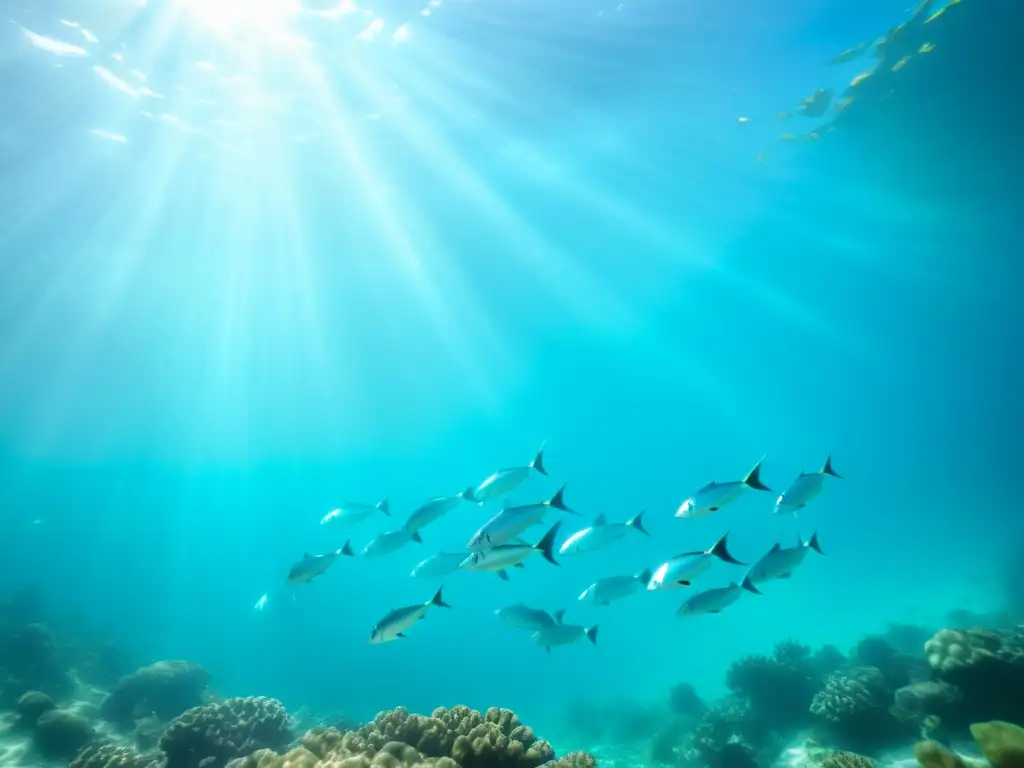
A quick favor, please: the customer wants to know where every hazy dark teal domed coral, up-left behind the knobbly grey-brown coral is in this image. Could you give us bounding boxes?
[100,660,210,724]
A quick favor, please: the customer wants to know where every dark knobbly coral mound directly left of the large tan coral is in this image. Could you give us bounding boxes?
[160,696,293,768]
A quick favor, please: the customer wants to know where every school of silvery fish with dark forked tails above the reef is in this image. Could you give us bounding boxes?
[278,444,841,651]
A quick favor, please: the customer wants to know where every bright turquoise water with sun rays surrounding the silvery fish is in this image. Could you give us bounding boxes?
[0,0,1022,745]
